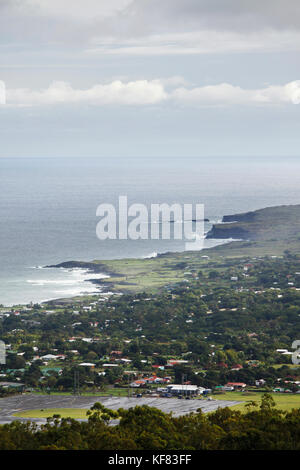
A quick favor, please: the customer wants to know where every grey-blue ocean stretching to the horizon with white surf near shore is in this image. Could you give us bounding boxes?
[0,158,300,305]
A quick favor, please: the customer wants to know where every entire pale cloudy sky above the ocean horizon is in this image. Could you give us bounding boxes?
[0,0,300,158]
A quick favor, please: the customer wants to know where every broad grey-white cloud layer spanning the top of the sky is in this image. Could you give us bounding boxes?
[0,0,300,55]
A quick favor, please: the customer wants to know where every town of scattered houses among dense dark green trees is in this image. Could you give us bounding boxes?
[0,253,300,406]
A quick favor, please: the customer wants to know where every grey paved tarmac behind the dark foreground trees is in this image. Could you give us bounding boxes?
[0,394,239,424]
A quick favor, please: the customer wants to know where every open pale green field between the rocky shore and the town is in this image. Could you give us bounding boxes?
[64,239,300,300]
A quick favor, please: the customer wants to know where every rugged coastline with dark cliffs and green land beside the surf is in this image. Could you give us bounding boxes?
[3,205,300,305]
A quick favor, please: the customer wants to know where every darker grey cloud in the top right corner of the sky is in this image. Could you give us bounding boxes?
[123,0,300,31]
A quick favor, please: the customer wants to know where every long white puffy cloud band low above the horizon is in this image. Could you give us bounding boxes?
[0,77,300,107]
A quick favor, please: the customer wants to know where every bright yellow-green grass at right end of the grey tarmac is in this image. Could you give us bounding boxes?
[213,392,300,411]
